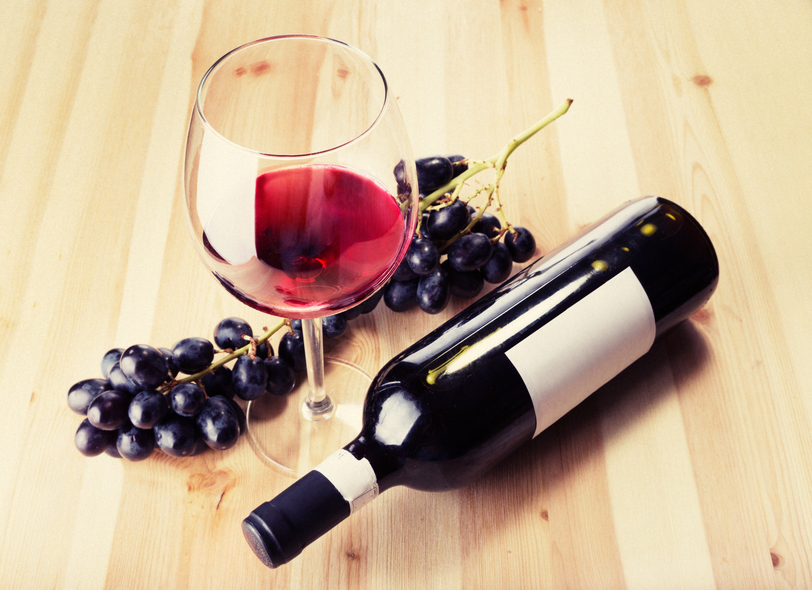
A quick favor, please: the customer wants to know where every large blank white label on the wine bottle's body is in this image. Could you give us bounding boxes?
[506,268,656,437]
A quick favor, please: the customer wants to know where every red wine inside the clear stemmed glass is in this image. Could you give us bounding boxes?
[207,165,408,318]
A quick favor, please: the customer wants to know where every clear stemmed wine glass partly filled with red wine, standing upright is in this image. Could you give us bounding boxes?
[184,35,418,475]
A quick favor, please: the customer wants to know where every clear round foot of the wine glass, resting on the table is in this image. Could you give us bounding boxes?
[245,357,372,477]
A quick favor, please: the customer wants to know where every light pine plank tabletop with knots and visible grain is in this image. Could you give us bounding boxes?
[0,0,812,590]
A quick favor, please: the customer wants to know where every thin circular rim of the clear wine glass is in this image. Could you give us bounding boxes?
[194,34,389,160]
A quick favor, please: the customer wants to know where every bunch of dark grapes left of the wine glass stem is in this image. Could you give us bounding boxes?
[68,318,304,461]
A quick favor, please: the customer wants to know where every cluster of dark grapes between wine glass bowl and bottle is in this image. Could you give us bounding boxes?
[382,155,536,314]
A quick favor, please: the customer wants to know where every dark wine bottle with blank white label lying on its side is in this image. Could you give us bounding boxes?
[242,197,719,567]
